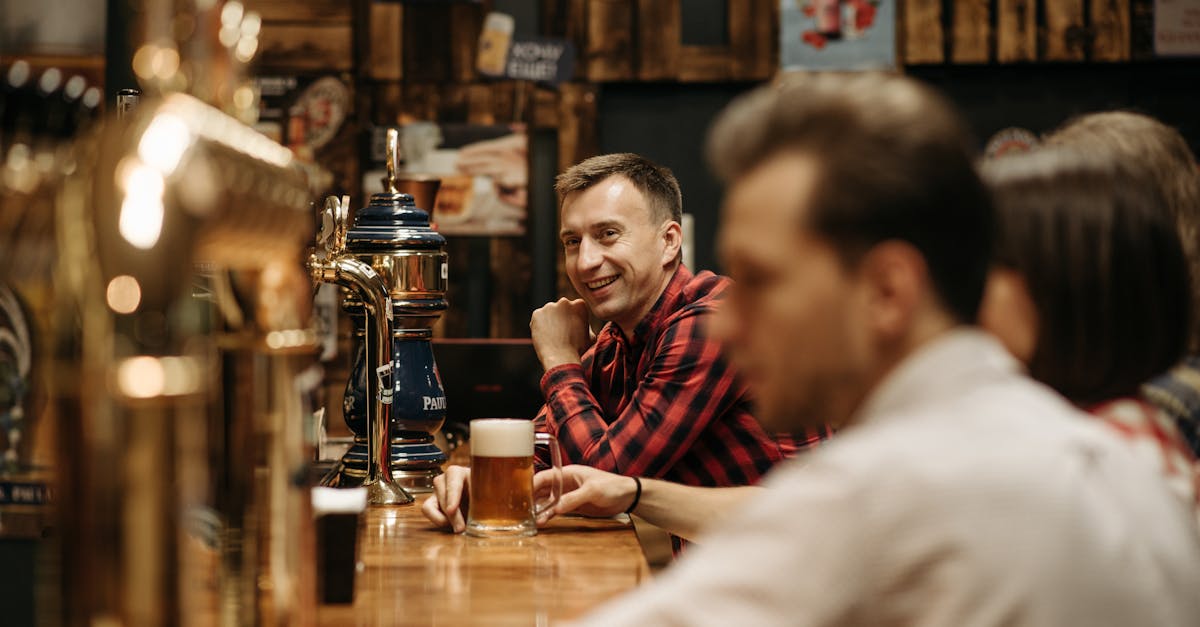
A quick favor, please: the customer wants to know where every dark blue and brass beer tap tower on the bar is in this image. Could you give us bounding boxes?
[316,130,446,492]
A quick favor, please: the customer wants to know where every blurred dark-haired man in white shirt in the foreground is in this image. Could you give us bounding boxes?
[544,74,1200,627]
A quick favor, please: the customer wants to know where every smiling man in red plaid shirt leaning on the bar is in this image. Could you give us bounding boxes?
[529,154,817,485]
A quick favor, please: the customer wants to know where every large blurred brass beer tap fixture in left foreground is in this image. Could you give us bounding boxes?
[46,88,319,626]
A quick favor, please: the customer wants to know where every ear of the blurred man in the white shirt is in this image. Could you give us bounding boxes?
[859,240,934,339]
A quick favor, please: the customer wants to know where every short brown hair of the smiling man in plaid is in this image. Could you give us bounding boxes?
[554,153,683,225]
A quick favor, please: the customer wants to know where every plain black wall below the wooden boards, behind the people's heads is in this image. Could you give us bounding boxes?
[599,60,1200,270]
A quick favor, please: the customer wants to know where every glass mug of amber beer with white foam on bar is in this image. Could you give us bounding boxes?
[467,418,563,537]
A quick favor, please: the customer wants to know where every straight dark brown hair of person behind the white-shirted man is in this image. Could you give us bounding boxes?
[983,149,1192,404]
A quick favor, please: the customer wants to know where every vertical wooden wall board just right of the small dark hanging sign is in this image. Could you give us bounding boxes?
[583,0,634,82]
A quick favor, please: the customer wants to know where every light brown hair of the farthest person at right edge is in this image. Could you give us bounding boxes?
[1045,111,1200,351]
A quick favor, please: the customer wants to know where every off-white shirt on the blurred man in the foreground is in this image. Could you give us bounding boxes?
[568,330,1200,627]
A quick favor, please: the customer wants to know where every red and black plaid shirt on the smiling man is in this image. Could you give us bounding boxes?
[536,265,820,486]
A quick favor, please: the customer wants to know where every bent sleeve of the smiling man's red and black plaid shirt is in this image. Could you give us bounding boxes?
[536,315,740,477]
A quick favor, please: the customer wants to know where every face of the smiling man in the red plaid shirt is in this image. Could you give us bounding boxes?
[559,174,679,334]
